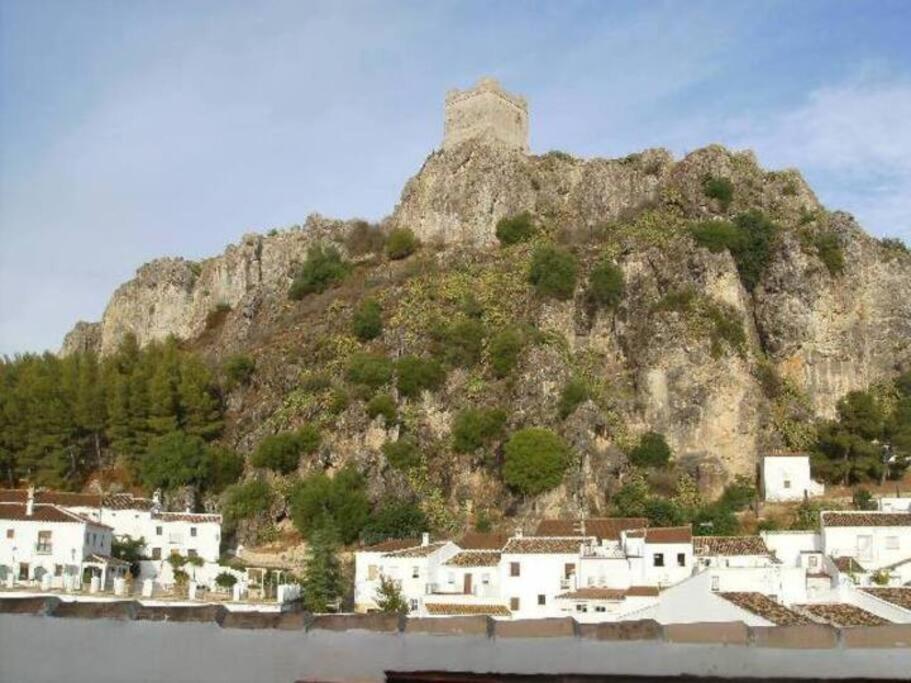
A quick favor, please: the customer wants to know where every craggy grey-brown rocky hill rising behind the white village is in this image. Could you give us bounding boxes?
[63,140,911,524]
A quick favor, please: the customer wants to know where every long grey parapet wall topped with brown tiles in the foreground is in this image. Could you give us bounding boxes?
[0,597,911,683]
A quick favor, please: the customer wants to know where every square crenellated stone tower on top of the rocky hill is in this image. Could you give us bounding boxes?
[443,78,528,154]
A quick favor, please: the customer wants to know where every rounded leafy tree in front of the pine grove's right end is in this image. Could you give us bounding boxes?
[141,432,210,491]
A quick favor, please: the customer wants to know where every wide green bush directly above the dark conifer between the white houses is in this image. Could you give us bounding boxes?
[288,467,370,543]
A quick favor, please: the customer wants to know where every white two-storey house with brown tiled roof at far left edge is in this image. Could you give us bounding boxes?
[0,494,128,590]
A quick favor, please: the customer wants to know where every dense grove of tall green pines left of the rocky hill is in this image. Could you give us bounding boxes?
[0,336,227,488]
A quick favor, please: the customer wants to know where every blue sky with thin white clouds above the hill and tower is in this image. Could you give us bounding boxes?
[0,0,911,353]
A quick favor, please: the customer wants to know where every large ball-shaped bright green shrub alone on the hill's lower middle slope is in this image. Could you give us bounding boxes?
[503,427,571,496]
